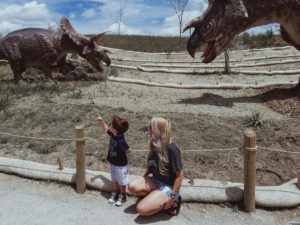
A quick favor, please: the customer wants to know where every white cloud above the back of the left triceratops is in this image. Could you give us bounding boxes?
[0,1,53,35]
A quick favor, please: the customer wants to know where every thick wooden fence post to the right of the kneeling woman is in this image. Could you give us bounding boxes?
[244,128,256,212]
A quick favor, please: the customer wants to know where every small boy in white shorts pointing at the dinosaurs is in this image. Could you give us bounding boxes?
[97,115,131,206]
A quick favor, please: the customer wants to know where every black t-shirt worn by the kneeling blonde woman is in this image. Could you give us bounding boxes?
[148,143,182,186]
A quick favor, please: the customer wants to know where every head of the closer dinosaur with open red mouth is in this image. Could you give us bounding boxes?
[183,0,248,63]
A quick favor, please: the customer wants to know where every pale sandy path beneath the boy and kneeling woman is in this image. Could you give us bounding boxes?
[0,173,300,225]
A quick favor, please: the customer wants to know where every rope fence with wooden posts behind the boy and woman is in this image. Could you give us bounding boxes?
[0,124,300,212]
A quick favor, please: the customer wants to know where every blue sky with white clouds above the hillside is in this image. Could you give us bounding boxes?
[0,0,276,36]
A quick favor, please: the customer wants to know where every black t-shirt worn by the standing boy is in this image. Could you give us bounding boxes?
[107,129,129,166]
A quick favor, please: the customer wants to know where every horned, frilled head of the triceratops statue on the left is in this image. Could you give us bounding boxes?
[61,17,111,72]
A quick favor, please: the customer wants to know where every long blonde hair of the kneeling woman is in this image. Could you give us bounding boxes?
[148,117,171,174]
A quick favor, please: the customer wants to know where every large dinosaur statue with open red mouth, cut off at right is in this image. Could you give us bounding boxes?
[183,0,300,63]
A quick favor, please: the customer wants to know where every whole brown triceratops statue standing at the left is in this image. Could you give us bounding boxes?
[0,17,111,82]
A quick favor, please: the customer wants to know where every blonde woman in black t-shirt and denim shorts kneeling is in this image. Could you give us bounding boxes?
[128,117,183,216]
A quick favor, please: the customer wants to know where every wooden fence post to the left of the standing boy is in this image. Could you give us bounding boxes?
[75,124,86,194]
